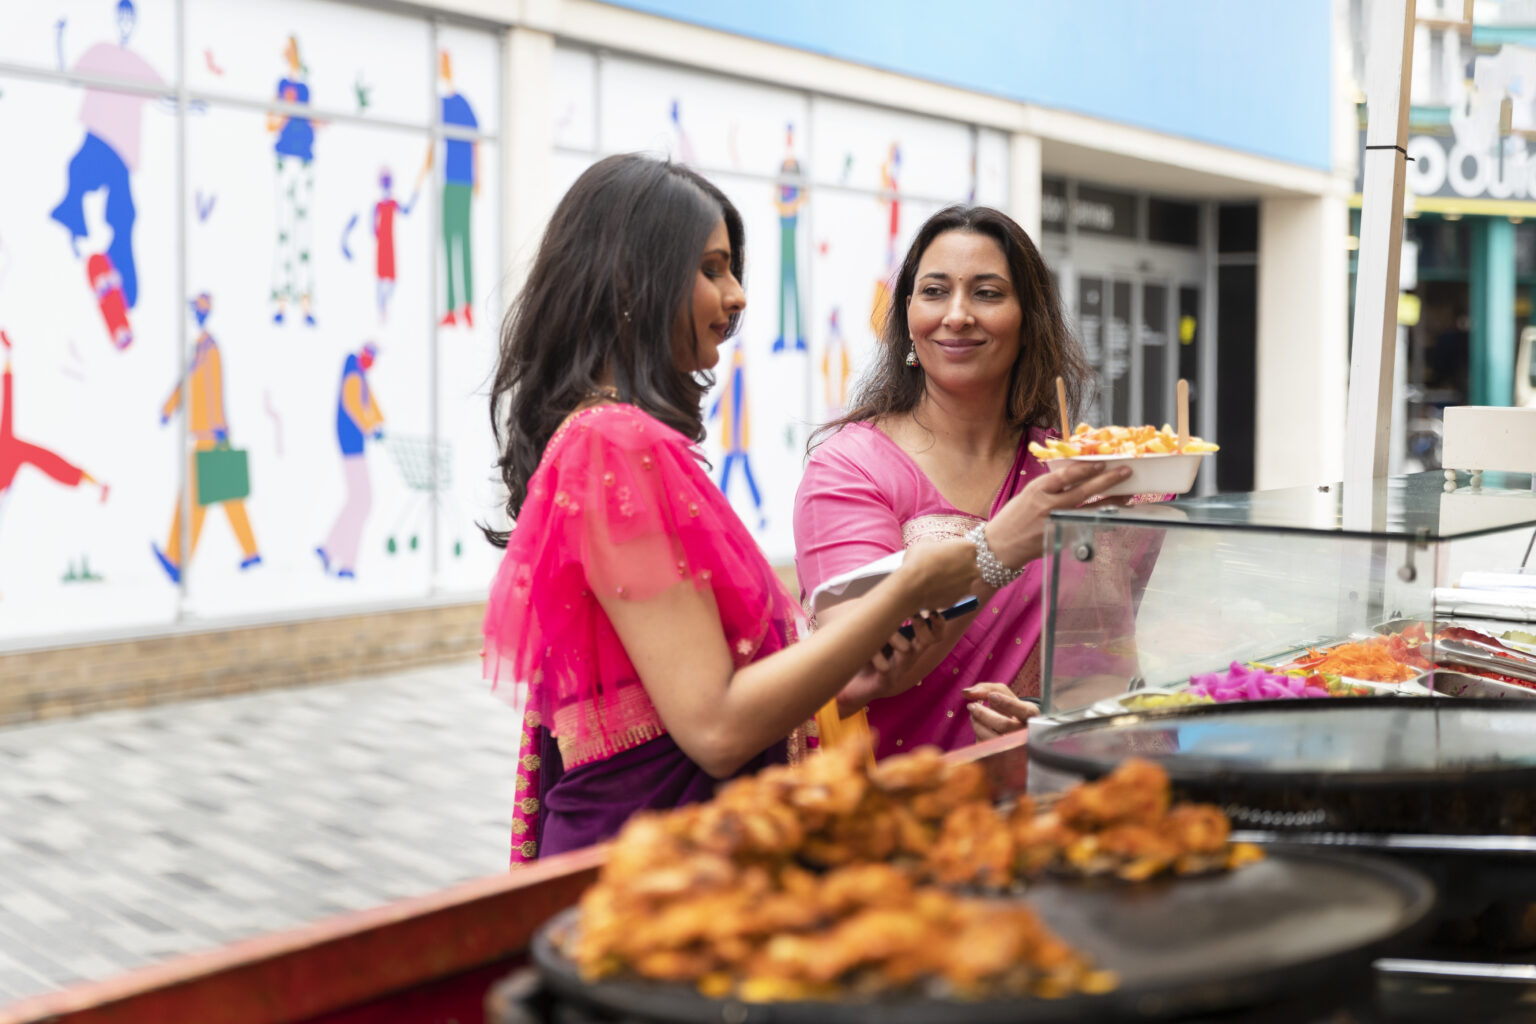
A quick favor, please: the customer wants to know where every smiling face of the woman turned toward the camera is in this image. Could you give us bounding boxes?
[906,230,1025,391]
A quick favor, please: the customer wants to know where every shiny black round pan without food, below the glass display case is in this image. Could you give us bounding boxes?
[1029,697,1536,835]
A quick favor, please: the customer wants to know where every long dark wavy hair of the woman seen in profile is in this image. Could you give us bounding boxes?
[485,154,745,547]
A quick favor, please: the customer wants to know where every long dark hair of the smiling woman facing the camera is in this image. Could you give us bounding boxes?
[808,204,1094,448]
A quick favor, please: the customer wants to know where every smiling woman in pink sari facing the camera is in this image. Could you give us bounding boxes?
[794,206,1129,757]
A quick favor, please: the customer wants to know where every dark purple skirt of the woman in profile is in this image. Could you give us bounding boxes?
[539,728,790,857]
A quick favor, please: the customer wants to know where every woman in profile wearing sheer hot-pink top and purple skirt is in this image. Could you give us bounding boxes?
[485,155,980,863]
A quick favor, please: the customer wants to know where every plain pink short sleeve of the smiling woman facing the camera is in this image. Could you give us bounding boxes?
[794,442,903,600]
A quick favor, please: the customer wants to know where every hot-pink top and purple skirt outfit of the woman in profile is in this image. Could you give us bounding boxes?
[485,405,802,864]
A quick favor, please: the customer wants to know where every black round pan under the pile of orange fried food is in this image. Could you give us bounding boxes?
[533,851,1435,1024]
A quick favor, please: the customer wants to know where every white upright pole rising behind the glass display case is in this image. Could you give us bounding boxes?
[1344,0,1416,530]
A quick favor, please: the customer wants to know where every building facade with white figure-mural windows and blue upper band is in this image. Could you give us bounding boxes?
[0,0,1355,712]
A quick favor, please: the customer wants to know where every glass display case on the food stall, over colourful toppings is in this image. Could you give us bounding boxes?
[1041,471,1536,717]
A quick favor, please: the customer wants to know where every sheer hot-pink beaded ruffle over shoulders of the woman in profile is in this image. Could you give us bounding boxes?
[485,405,796,746]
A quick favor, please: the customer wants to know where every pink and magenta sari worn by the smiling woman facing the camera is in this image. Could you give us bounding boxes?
[794,422,1049,757]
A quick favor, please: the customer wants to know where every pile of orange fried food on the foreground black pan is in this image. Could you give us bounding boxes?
[562,748,1261,1001]
